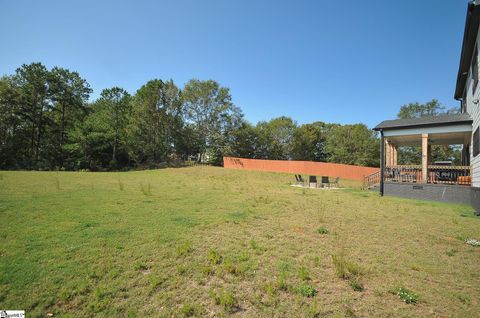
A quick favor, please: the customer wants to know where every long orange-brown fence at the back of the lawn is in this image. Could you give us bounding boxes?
[223,157,380,181]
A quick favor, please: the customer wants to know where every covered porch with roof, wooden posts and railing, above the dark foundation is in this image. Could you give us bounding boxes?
[375,114,472,194]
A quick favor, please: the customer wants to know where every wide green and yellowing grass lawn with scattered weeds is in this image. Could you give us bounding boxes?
[0,167,480,317]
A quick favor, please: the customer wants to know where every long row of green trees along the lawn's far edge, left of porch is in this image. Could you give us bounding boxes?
[0,63,379,171]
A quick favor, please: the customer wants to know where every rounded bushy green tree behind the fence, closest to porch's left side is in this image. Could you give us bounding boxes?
[325,124,380,167]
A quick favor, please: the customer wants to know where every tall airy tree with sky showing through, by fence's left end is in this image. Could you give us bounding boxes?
[182,79,243,164]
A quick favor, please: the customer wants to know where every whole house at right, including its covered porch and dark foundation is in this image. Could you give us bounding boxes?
[365,1,480,212]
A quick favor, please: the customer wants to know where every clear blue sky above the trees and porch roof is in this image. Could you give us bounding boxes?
[0,0,467,127]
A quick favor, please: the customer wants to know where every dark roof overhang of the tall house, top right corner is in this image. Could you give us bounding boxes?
[454,1,480,99]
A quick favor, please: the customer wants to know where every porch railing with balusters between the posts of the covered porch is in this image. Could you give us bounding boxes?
[385,165,472,185]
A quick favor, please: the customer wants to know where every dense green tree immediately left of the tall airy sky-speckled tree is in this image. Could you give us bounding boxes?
[128,79,182,164]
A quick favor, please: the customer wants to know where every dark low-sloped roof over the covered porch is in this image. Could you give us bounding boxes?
[373,113,473,131]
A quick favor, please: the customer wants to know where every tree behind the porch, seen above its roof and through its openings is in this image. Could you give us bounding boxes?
[397,99,461,164]
